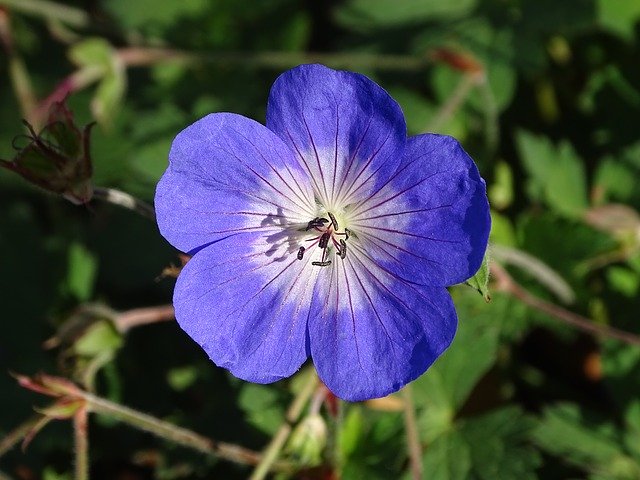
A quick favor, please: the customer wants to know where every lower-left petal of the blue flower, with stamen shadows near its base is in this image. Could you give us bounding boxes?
[173,229,318,383]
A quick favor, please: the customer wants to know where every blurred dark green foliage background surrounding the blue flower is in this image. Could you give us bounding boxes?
[0,0,640,480]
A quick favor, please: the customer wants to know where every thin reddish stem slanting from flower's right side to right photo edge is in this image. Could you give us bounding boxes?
[491,262,640,346]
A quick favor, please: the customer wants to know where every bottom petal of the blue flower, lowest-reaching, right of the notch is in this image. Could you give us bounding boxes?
[308,253,457,401]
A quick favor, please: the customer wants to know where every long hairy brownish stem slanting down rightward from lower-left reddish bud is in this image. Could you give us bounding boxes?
[79,392,293,472]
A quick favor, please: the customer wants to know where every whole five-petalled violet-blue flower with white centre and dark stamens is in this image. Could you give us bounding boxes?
[155,65,490,401]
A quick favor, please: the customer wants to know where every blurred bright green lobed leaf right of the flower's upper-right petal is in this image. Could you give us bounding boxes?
[516,130,588,218]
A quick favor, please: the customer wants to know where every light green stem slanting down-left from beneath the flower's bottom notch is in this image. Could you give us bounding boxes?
[249,370,319,480]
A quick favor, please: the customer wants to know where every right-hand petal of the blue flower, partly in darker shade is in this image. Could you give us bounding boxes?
[350,134,491,286]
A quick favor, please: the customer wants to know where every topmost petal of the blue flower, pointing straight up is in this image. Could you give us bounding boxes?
[267,65,406,209]
